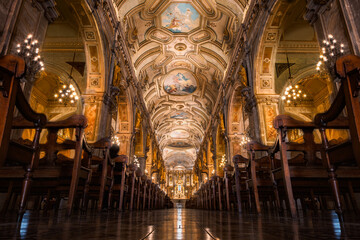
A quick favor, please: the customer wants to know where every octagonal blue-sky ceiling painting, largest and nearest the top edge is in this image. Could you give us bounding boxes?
[161,3,200,33]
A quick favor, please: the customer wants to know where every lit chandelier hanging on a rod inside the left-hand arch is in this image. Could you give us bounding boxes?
[54,53,79,106]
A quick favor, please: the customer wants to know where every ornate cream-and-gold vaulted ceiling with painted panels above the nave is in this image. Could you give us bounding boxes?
[115,0,247,169]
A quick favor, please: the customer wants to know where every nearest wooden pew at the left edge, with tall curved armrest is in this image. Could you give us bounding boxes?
[0,55,47,221]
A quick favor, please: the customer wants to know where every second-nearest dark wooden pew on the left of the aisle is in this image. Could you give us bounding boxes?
[13,115,92,215]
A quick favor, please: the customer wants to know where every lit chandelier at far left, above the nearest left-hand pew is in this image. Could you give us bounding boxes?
[16,34,45,76]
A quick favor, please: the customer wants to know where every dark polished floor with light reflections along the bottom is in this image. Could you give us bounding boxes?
[0,208,360,240]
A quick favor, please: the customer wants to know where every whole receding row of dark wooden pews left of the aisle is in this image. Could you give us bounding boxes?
[0,55,172,221]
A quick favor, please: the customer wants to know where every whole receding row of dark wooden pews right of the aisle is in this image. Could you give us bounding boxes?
[187,55,360,222]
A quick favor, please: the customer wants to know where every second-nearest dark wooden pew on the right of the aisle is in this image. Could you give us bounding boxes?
[273,115,356,220]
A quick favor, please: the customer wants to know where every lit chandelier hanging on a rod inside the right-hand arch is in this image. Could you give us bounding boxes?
[281,53,307,105]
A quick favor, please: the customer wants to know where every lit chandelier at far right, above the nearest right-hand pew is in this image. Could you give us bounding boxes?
[316,34,345,77]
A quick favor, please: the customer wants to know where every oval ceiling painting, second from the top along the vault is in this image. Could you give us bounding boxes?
[164,70,197,96]
